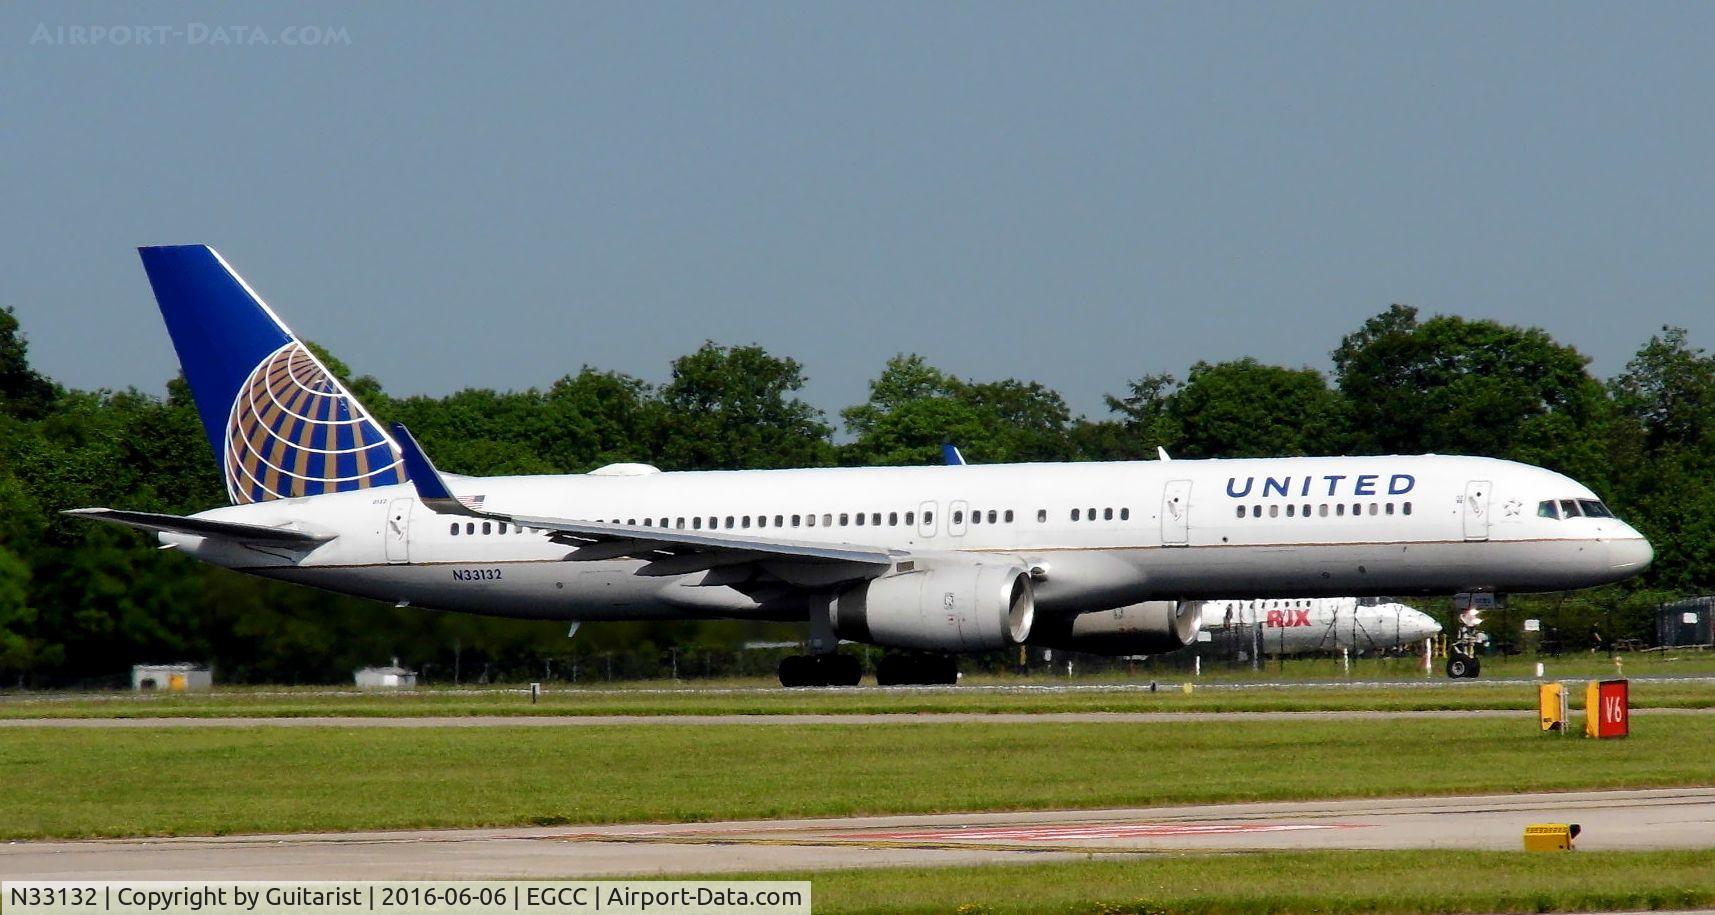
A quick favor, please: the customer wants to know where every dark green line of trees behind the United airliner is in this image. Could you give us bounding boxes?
[0,305,1715,685]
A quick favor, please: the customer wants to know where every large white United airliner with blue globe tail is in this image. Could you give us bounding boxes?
[72,245,1653,685]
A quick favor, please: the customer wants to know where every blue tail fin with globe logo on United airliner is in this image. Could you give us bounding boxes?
[139,245,406,504]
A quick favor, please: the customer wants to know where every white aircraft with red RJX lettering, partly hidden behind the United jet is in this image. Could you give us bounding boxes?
[1202,598,1441,655]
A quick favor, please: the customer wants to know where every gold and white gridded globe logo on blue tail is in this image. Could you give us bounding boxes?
[225,341,406,504]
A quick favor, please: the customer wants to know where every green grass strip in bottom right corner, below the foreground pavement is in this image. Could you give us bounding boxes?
[754,850,1715,915]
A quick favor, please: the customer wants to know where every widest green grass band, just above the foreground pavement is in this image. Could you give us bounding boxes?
[0,716,1710,838]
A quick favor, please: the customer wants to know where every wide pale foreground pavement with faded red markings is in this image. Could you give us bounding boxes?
[13,788,1715,881]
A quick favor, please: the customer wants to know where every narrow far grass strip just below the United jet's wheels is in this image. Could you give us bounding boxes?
[0,661,1715,718]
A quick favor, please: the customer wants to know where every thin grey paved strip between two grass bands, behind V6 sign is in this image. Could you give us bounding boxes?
[0,708,1715,728]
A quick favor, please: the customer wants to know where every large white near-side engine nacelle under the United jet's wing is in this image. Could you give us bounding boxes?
[828,562,1036,651]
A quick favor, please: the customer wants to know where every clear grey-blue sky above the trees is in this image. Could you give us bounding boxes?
[0,2,1715,413]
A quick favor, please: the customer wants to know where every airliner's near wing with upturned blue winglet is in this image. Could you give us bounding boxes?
[393,423,904,584]
